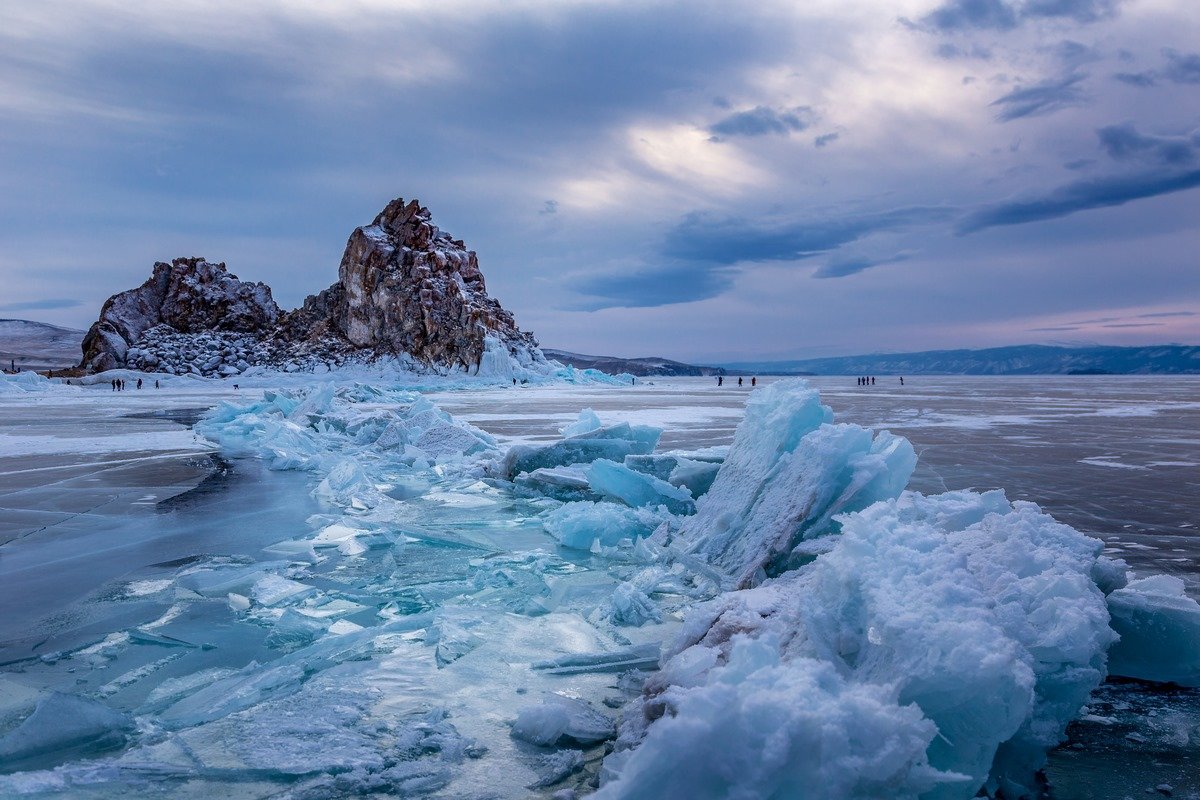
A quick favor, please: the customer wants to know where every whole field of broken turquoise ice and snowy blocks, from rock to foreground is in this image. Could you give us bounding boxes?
[0,380,1200,798]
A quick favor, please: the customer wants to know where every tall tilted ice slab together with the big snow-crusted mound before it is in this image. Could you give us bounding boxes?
[598,381,1190,799]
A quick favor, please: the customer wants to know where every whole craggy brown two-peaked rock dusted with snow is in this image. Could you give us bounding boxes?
[82,199,546,375]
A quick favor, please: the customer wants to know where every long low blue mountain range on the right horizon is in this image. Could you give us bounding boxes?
[724,344,1200,375]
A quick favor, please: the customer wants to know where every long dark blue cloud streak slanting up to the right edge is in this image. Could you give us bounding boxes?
[958,169,1200,234]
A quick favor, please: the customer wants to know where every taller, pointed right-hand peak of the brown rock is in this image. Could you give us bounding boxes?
[321,198,538,368]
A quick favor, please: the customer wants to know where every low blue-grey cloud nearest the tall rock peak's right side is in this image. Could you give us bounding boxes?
[576,264,737,311]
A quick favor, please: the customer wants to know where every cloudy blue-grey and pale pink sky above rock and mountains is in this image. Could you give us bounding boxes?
[0,0,1200,362]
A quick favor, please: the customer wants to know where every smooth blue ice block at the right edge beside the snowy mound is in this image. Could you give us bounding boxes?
[1109,575,1200,686]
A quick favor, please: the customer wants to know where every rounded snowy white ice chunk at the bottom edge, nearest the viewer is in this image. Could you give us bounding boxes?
[593,640,973,800]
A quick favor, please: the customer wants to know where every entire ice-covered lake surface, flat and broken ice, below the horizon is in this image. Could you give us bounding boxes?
[0,374,1200,798]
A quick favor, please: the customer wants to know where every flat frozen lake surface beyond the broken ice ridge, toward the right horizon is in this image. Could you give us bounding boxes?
[433,375,1200,591]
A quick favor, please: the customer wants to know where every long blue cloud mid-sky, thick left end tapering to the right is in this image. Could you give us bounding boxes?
[662,206,952,265]
